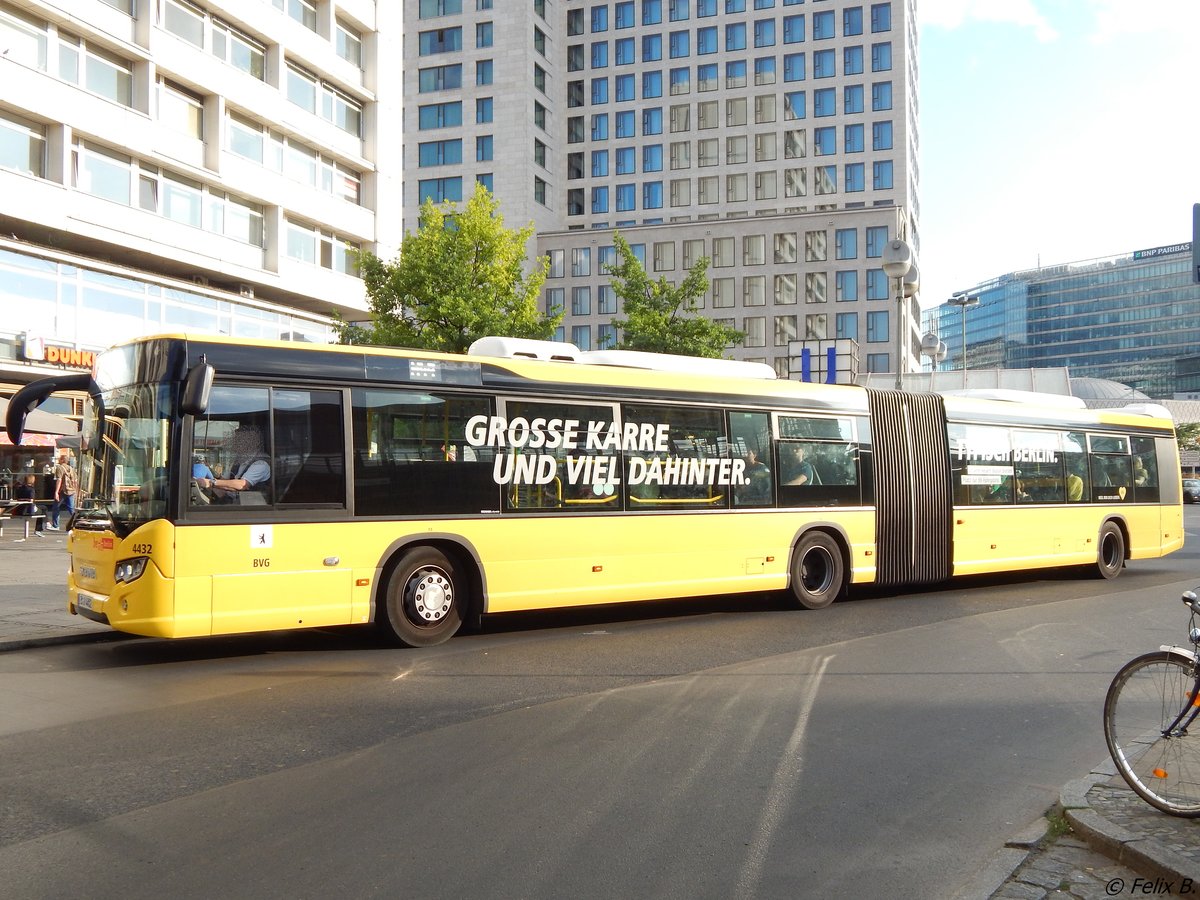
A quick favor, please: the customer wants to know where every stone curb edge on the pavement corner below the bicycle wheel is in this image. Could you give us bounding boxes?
[1058,760,1200,882]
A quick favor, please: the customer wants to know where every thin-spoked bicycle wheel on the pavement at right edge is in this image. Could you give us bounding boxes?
[1104,650,1200,818]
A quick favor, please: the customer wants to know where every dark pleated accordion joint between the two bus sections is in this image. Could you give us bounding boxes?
[866,389,953,586]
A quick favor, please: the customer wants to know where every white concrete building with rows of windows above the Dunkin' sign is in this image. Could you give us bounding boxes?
[0,0,403,398]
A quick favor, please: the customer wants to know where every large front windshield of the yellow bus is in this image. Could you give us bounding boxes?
[79,384,174,534]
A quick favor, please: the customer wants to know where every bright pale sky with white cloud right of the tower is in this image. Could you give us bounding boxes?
[917,0,1200,308]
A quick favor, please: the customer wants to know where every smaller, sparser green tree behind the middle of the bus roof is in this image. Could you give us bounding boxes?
[611,233,745,359]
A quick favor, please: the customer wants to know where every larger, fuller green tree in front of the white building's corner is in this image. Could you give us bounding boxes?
[338,184,562,353]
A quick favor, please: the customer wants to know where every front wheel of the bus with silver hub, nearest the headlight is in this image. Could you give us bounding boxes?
[376,547,467,647]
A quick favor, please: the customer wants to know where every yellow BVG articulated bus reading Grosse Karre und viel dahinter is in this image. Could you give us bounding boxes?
[6,335,1183,647]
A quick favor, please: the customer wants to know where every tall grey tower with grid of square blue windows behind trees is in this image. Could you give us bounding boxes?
[404,0,919,376]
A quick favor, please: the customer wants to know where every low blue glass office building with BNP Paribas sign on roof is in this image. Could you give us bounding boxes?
[925,244,1200,400]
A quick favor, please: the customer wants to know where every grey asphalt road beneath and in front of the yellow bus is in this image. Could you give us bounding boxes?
[0,510,1200,898]
